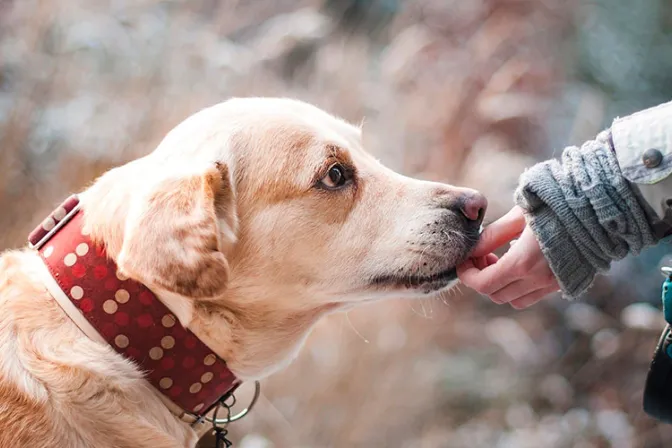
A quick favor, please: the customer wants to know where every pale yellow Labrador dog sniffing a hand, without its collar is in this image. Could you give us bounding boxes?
[0,98,486,448]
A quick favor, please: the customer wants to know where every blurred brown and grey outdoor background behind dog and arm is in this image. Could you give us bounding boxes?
[0,0,672,448]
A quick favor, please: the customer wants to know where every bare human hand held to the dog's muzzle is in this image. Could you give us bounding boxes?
[457,206,560,309]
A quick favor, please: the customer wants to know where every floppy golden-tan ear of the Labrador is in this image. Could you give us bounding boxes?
[117,163,237,298]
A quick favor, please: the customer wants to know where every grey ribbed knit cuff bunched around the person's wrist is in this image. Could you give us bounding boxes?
[515,132,657,298]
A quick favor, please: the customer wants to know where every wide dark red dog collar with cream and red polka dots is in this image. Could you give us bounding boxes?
[29,196,240,416]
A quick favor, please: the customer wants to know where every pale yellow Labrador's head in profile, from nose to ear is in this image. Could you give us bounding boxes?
[81,98,486,378]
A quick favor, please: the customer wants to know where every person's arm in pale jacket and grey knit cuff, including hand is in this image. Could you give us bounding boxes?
[458,103,672,307]
